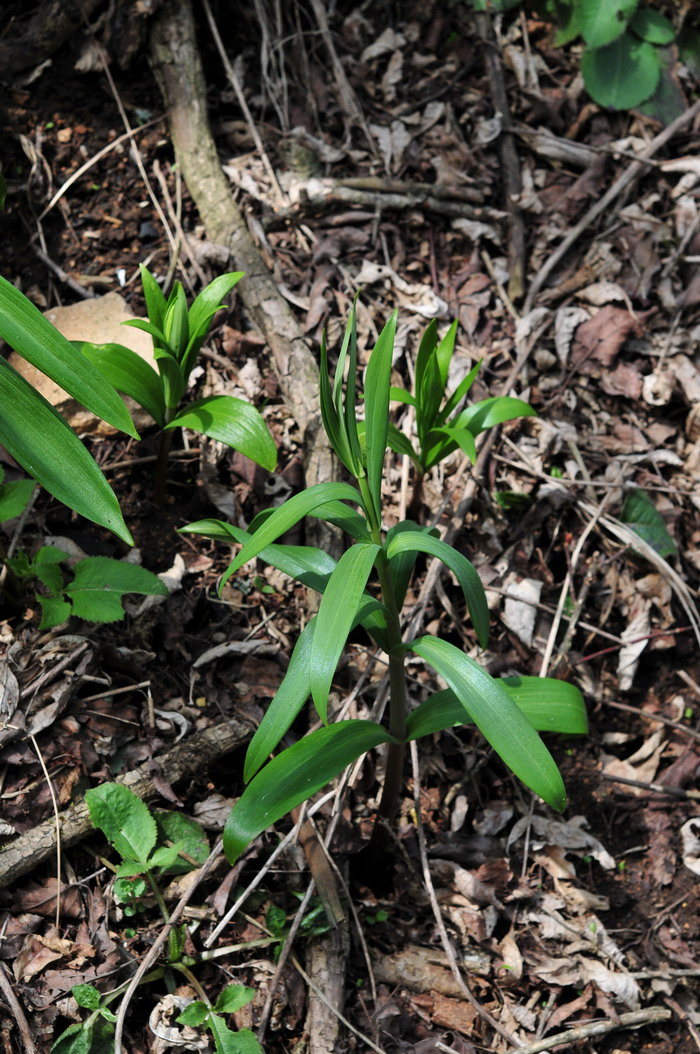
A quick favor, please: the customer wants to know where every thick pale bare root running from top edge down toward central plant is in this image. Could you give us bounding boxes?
[151,0,335,516]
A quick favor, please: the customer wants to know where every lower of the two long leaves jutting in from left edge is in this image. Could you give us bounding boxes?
[0,360,134,545]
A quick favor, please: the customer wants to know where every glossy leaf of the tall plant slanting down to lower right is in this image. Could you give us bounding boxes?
[411,637,566,809]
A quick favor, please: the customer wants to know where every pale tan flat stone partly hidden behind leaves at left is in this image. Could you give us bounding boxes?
[8,293,157,435]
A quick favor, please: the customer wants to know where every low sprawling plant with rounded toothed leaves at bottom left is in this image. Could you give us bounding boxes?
[71,783,263,1054]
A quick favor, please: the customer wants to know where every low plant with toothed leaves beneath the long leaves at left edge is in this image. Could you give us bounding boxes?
[6,543,168,629]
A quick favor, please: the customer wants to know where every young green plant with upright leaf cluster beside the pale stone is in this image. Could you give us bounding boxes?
[77,265,277,502]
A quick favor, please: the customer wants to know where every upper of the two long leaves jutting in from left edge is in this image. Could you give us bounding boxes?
[0,277,138,438]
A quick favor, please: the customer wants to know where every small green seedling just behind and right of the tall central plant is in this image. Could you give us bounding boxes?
[387,319,534,516]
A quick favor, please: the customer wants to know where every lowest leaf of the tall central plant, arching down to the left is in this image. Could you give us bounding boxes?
[223,721,392,863]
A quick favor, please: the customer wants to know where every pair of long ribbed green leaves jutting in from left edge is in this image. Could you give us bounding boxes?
[0,277,138,545]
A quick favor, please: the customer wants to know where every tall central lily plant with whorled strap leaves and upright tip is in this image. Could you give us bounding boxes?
[183,309,587,861]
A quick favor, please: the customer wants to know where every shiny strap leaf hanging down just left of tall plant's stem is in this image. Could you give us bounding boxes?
[309,542,381,723]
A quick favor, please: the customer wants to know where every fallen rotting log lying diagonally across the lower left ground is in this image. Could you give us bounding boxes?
[0,718,251,889]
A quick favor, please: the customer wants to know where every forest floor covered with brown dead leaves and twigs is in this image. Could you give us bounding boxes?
[0,0,700,1054]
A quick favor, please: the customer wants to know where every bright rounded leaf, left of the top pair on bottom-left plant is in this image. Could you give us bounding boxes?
[85,783,156,866]
